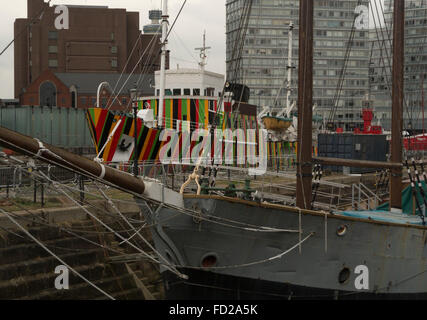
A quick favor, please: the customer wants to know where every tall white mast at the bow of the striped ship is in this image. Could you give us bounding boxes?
[157,0,169,128]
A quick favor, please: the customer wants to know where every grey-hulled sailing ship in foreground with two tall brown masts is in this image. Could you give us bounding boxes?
[82,1,427,299]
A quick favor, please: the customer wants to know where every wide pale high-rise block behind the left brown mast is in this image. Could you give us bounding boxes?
[226,0,370,129]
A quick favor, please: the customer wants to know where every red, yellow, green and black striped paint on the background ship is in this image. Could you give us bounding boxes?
[86,99,296,167]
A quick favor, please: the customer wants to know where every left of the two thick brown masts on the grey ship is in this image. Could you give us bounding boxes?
[296,0,313,209]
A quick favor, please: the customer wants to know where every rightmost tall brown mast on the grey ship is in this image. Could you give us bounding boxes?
[390,0,405,210]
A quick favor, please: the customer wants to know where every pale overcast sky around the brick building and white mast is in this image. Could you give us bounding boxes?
[0,0,225,99]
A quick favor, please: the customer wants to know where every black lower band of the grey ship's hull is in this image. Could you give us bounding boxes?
[163,270,427,301]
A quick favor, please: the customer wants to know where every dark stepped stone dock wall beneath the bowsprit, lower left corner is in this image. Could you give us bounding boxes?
[0,202,164,300]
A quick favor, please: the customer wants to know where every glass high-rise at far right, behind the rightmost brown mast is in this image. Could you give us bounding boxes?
[369,0,427,130]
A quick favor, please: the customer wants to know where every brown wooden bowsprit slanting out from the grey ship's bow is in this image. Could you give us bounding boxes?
[0,127,145,194]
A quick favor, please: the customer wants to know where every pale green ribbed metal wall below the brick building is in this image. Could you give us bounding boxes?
[0,106,93,149]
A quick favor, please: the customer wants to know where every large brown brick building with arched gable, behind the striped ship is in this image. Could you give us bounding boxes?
[14,0,169,107]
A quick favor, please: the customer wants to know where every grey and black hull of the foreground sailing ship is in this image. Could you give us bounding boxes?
[136,196,427,299]
